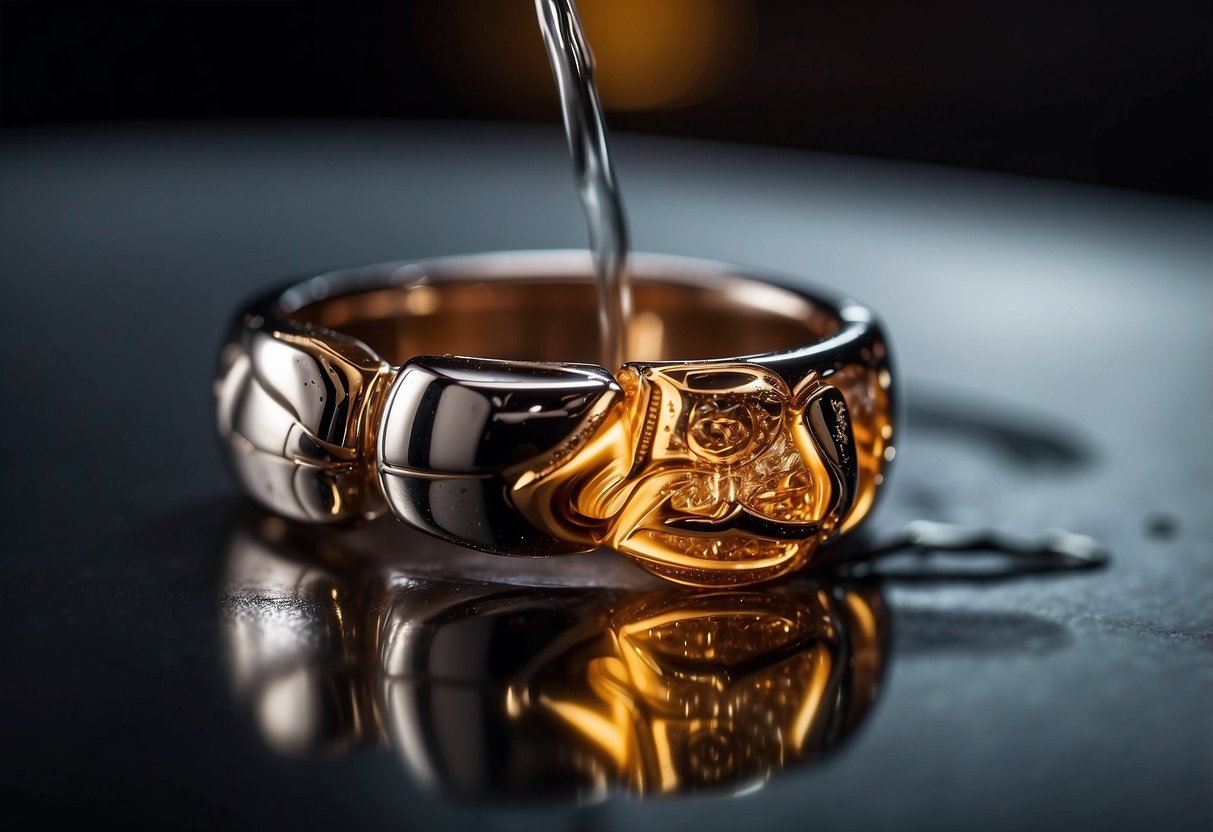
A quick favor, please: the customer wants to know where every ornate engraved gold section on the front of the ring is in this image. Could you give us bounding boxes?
[512,361,853,585]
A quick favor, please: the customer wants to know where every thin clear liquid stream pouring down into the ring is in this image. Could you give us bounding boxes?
[535,0,632,370]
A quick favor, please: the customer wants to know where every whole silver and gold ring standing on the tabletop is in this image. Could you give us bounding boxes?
[216,252,893,585]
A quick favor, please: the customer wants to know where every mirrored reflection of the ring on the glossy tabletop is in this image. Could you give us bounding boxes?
[223,514,888,802]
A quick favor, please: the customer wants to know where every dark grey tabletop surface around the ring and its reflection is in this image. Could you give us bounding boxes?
[0,122,1213,830]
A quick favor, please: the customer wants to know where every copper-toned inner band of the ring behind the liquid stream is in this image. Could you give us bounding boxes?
[289,274,841,365]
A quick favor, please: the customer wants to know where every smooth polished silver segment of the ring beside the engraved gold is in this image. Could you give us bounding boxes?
[377,355,619,554]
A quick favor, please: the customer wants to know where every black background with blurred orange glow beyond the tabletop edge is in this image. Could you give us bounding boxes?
[0,0,1213,198]
